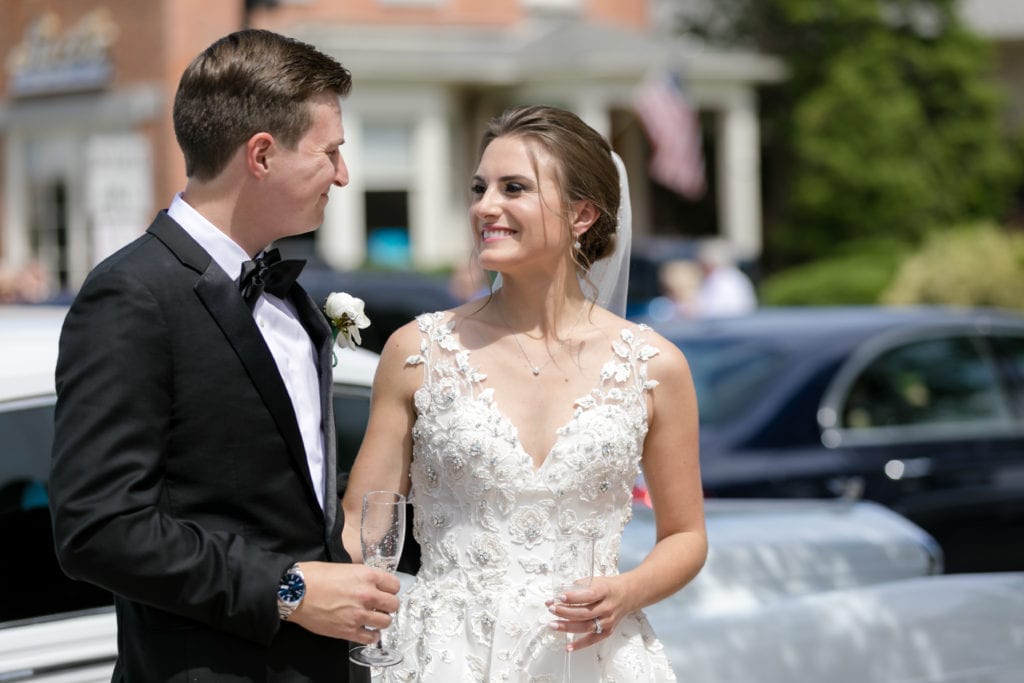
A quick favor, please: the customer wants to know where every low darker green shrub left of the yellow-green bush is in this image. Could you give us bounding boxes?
[759,239,910,306]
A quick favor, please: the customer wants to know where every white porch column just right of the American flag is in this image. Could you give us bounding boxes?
[718,90,762,260]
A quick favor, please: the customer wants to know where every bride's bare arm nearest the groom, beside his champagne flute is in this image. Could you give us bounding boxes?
[341,322,423,562]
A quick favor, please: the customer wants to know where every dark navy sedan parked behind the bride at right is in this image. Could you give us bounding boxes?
[650,307,1024,571]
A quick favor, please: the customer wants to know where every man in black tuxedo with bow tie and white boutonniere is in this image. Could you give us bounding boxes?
[49,30,398,683]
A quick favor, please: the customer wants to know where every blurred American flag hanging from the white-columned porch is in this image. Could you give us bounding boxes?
[633,74,706,200]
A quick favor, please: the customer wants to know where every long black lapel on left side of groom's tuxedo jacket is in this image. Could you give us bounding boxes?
[150,212,319,507]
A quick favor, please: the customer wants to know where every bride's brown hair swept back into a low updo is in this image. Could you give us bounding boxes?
[480,105,622,271]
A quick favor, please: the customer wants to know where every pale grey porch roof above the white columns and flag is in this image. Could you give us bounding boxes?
[289,17,784,86]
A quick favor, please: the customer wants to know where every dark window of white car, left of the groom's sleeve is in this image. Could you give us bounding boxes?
[0,398,114,623]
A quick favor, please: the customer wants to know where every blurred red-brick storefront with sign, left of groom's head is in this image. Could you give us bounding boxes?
[0,0,243,290]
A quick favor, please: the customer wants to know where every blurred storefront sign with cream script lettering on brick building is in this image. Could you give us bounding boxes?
[7,7,118,97]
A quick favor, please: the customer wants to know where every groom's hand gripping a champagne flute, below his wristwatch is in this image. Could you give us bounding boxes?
[288,562,401,645]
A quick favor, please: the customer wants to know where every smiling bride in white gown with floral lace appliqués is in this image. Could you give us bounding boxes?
[343,106,707,682]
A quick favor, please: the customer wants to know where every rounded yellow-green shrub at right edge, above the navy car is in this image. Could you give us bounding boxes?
[881,223,1024,309]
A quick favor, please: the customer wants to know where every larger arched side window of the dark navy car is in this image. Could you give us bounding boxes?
[842,336,1010,429]
